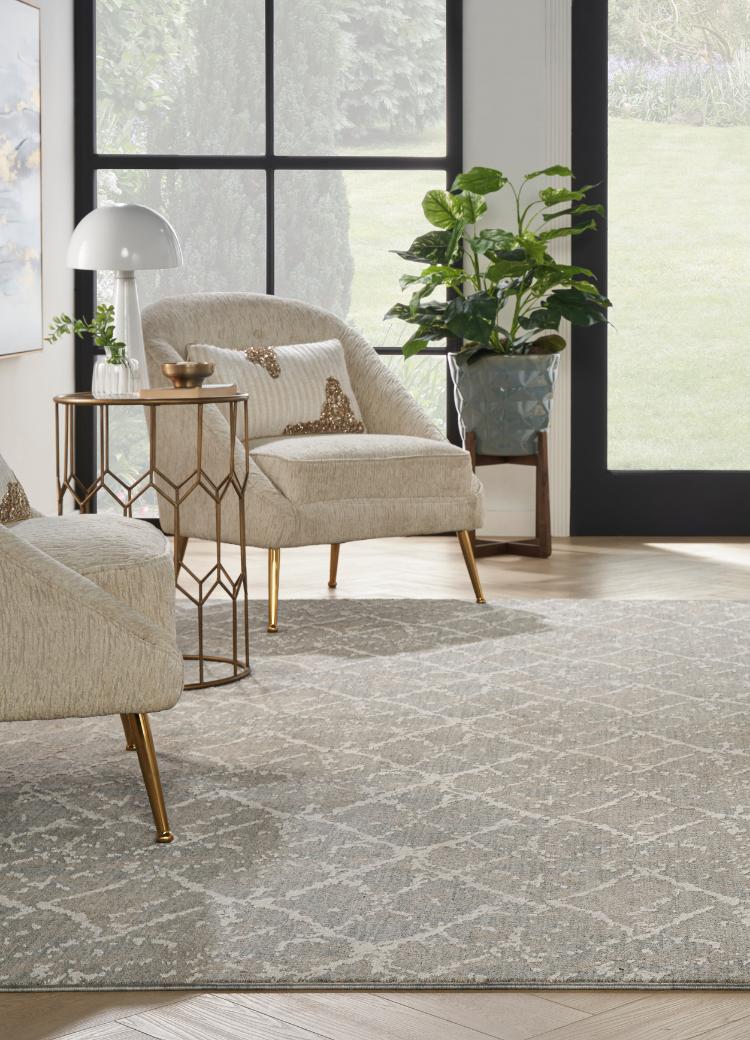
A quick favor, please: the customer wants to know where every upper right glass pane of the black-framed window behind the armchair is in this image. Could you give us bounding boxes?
[275,0,449,155]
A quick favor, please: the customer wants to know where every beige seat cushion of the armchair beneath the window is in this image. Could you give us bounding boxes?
[251,434,472,504]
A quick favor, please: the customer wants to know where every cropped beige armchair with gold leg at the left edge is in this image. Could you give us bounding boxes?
[0,516,183,843]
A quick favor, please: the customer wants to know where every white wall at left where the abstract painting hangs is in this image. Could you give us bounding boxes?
[0,0,74,513]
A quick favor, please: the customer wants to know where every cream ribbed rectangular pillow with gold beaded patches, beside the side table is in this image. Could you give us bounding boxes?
[187,339,365,440]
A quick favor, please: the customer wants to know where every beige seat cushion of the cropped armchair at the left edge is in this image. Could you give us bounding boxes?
[14,515,175,633]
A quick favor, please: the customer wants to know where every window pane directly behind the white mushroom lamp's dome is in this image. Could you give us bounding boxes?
[99,170,265,307]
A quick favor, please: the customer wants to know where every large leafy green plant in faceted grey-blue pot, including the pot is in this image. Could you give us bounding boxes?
[386,166,611,456]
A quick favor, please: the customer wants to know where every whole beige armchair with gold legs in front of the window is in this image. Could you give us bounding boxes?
[143,293,485,631]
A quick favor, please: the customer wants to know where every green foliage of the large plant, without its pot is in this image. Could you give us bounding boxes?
[386,165,611,362]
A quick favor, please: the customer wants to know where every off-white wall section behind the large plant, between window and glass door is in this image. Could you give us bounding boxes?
[464,0,570,535]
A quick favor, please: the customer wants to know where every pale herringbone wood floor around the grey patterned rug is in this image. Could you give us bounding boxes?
[5,538,750,1040]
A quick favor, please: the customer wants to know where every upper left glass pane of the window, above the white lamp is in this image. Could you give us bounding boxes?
[96,0,265,155]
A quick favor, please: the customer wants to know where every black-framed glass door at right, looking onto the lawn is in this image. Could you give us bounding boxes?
[571,0,750,536]
